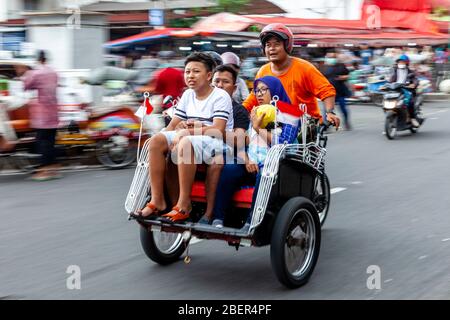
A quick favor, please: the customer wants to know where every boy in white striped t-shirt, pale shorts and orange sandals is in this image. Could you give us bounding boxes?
[137,53,233,222]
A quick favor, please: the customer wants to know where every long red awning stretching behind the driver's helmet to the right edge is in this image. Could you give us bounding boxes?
[193,11,448,45]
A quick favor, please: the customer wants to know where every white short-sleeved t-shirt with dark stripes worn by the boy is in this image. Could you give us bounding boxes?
[175,88,234,131]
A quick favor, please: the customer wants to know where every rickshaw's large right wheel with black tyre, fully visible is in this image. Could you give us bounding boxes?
[270,197,321,288]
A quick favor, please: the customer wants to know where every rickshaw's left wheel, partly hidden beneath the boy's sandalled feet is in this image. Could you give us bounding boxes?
[140,226,187,265]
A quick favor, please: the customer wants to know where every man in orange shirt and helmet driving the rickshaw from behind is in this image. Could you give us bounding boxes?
[243,23,340,128]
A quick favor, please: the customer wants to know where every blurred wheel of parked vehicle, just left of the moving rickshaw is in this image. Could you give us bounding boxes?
[95,135,137,169]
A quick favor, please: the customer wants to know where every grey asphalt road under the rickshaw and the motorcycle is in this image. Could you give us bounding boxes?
[0,101,450,299]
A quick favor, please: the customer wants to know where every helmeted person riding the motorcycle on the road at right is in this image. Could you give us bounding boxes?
[390,54,420,128]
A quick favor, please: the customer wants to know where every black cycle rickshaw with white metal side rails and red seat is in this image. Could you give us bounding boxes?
[125,100,330,288]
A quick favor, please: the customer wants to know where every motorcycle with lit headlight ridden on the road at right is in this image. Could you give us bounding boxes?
[380,83,425,140]
